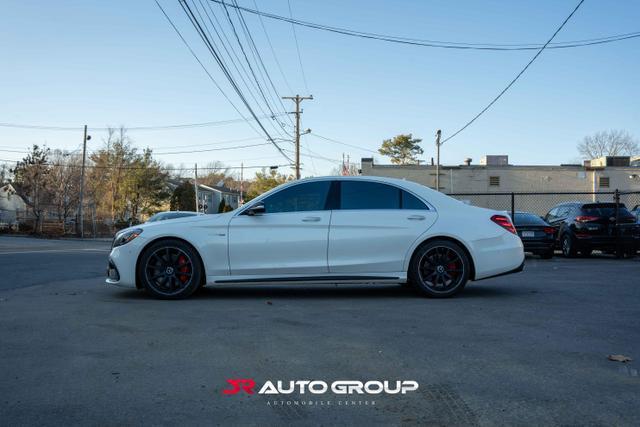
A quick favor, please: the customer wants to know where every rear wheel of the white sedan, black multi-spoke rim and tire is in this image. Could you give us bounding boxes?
[408,240,471,298]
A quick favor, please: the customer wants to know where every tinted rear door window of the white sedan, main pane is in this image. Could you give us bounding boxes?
[340,181,400,209]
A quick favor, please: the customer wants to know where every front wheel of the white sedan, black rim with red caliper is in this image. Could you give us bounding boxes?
[137,239,204,299]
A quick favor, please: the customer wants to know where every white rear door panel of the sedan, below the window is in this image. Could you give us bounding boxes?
[329,209,436,274]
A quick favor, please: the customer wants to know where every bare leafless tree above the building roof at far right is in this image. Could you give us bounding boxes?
[578,129,640,159]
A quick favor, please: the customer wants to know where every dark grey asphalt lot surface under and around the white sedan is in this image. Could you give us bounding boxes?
[0,237,640,425]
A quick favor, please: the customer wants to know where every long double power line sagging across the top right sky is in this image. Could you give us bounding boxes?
[209,0,640,51]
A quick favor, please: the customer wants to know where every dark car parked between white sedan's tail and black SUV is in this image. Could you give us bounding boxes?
[513,212,556,259]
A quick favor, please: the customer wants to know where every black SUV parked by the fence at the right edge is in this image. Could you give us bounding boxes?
[544,202,640,257]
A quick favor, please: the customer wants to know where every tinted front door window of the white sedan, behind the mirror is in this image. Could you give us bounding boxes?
[264,181,331,213]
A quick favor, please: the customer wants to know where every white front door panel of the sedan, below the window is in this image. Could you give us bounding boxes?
[229,211,331,275]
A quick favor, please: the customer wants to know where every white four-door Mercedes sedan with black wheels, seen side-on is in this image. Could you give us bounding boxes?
[107,177,524,299]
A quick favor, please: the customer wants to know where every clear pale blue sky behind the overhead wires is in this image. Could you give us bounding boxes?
[0,0,640,175]
